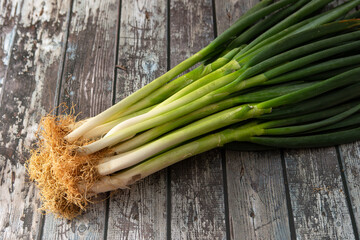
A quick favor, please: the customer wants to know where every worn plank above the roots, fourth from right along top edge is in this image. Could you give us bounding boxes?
[60,0,119,119]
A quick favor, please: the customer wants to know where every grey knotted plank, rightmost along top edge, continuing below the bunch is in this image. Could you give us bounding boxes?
[215,0,290,239]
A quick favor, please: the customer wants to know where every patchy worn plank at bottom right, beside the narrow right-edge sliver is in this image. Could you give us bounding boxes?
[284,148,354,239]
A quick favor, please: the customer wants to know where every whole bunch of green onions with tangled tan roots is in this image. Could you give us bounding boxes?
[27,0,360,219]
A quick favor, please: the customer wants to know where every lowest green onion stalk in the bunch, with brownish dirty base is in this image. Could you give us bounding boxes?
[92,119,360,193]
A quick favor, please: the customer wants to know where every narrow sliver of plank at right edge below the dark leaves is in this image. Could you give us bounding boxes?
[339,142,360,234]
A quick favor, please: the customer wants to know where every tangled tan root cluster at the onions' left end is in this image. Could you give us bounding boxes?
[27,112,104,219]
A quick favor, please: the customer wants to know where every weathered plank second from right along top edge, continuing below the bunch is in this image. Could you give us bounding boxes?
[170,0,226,239]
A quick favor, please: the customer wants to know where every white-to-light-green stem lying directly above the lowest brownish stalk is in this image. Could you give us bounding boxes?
[97,105,271,175]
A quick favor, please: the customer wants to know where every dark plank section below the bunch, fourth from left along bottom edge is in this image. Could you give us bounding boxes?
[170,150,226,239]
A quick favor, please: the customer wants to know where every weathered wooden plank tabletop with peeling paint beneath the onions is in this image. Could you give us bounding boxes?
[0,0,360,239]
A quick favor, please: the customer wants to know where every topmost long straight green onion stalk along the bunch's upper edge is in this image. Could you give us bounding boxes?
[65,0,295,142]
